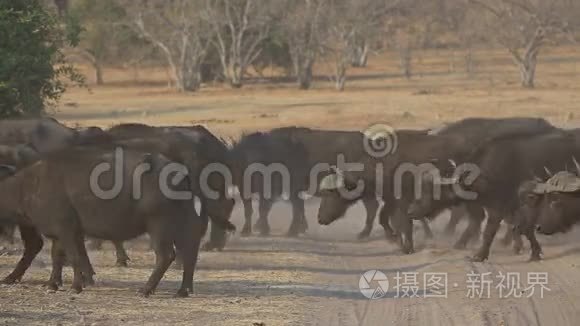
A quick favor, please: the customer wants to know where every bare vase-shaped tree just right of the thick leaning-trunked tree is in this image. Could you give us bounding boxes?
[204,0,272,88]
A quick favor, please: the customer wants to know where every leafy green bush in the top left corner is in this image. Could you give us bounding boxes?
[0,0,82,118]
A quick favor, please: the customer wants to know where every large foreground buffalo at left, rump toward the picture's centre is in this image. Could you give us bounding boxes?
[0,148,202,296]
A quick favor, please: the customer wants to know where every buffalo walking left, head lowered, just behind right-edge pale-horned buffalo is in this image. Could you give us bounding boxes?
[408,130,580,261]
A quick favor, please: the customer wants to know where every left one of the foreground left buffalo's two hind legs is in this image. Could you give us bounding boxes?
[140,219,174,297]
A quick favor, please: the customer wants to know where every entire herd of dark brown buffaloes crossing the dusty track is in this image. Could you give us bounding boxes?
[0,117,580,296]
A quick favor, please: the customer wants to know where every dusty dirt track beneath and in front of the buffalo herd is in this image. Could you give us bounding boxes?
[0,200,580,325]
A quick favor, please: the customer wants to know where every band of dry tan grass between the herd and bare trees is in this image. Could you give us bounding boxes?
[56,48,580,136]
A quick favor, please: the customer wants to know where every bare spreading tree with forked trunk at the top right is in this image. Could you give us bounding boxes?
[467,0,578,88]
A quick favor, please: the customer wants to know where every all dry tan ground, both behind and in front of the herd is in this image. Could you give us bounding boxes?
[0,48,580,325]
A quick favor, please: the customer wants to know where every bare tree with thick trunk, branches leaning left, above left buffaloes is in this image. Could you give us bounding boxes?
[122,0,212,91]
